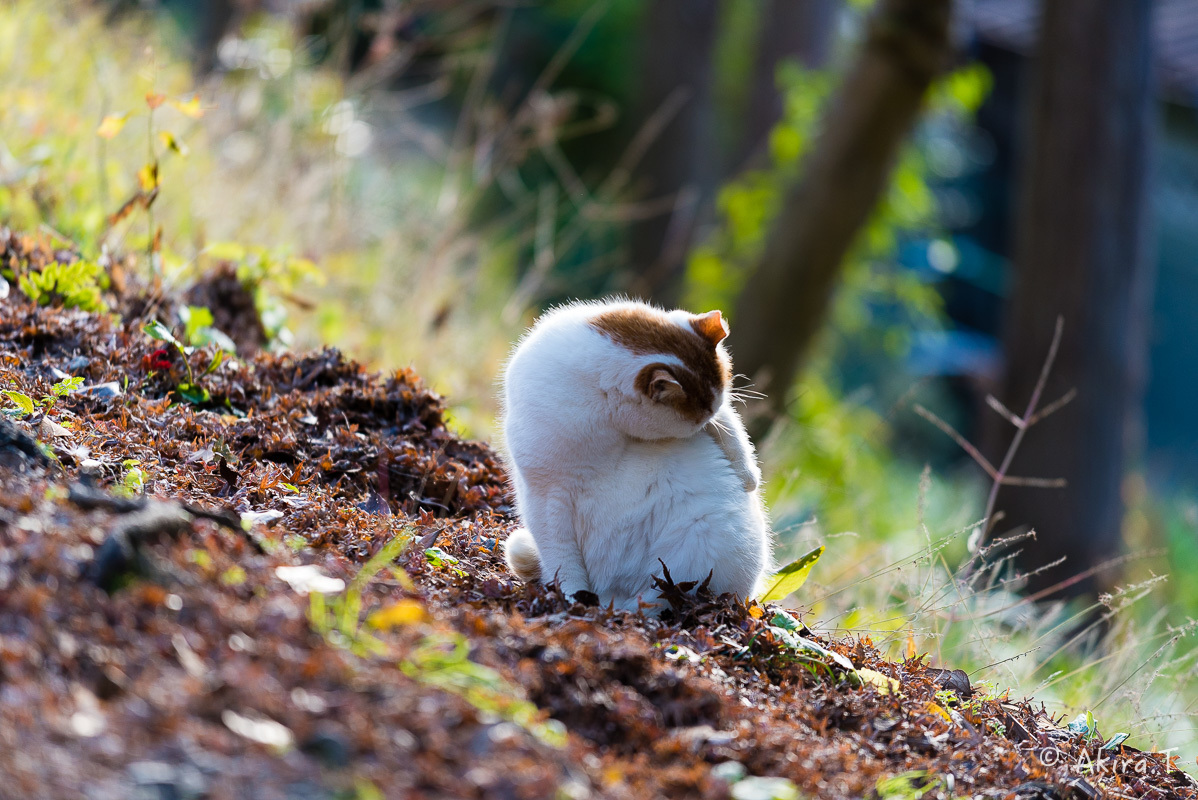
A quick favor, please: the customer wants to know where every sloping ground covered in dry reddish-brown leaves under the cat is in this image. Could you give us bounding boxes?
[0,230,1198,800]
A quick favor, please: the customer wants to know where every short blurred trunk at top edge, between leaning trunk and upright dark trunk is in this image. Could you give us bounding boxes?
[733,0,840,168]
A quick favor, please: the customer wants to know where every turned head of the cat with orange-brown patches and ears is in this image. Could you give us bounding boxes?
[589,303,732,440]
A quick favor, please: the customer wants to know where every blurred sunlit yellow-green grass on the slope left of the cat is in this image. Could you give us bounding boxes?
[0,0,526,436]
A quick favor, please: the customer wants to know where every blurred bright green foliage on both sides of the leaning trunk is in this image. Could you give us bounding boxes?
[685,65,990,537]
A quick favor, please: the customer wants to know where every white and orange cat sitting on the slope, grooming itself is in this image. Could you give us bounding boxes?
[503,301,770,610]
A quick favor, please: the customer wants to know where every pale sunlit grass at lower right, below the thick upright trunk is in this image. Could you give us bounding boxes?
[783,459,1198,772]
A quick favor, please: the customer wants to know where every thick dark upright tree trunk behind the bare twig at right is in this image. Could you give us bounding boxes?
[990,0,1152,594]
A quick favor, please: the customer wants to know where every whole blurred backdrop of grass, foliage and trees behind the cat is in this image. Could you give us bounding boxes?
[0,0,1198,757]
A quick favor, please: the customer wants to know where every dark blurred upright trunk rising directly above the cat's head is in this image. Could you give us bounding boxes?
[629,0,720,308]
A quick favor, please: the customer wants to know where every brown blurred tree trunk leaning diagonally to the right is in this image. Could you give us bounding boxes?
[730,0,952,410]
